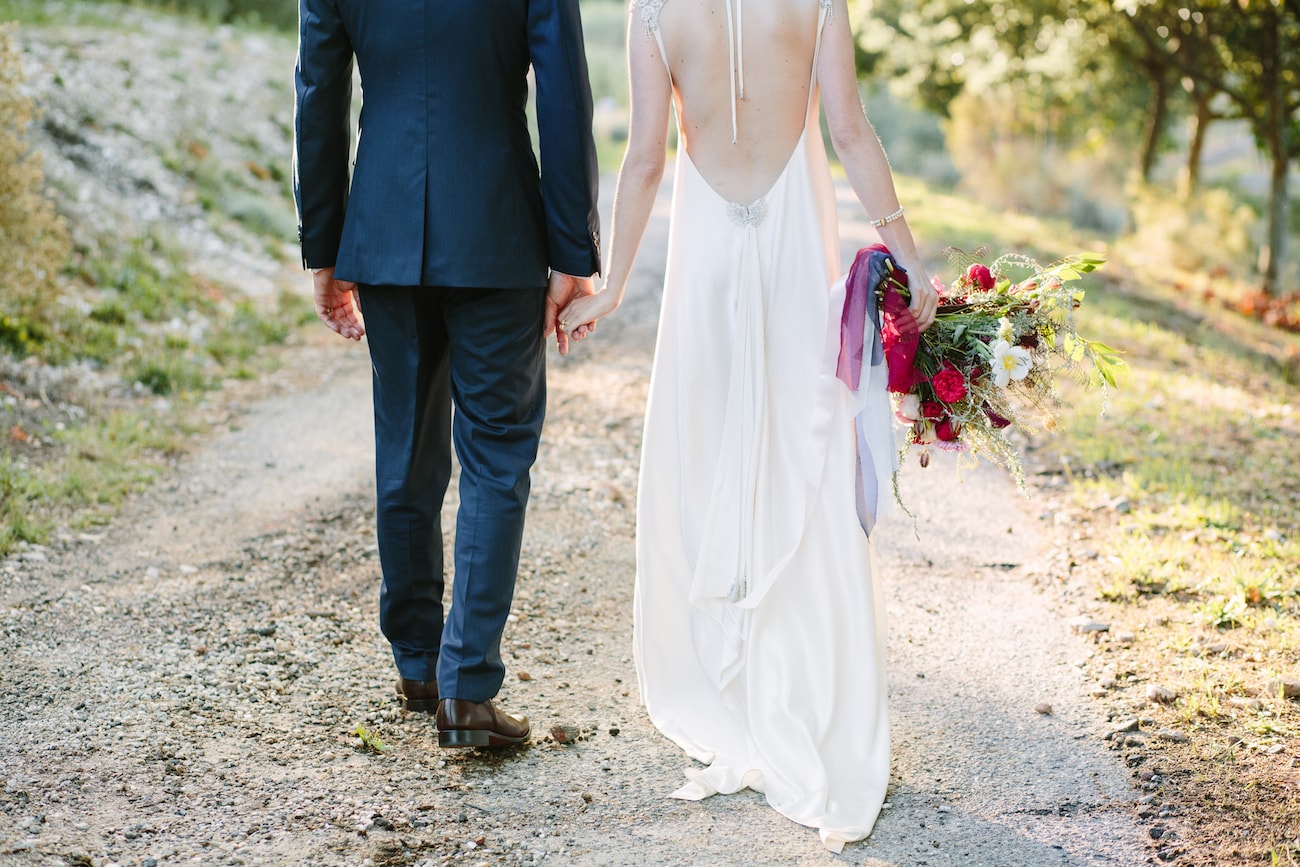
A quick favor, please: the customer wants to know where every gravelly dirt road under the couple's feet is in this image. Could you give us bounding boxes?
[0,179,1148,867]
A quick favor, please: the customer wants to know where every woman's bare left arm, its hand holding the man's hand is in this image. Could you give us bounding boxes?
[560,5,672,339]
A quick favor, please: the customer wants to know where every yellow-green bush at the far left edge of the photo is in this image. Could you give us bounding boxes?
[0,25,69,355]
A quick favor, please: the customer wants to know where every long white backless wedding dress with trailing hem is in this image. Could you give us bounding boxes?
[634,0,893,851]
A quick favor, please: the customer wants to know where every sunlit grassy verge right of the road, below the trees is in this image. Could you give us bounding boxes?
[900,188,1300,864]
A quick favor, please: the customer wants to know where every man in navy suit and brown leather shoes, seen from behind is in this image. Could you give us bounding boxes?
[294,0,599,746]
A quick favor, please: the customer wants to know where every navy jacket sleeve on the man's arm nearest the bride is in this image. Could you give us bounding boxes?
[528,0,601,277]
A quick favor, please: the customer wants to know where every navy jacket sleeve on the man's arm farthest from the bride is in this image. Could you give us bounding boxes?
[294,0,352,268]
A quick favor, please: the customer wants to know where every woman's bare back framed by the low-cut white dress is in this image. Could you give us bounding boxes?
[655,0,819,204]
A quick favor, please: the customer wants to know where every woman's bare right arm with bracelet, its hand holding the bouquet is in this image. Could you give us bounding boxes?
[816,0,939,330]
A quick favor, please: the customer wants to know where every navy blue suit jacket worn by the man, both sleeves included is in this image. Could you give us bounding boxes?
[294,0,599,289]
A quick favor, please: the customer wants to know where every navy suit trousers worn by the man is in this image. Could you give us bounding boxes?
[360,286,546,702]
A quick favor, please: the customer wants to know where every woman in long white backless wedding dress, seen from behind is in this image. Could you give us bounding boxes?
[560,0,937,851]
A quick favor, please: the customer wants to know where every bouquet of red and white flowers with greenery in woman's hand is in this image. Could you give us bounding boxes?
[847,248,1123,497]
